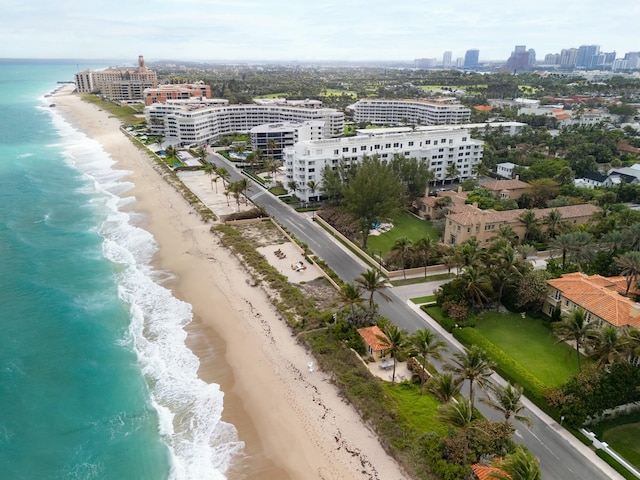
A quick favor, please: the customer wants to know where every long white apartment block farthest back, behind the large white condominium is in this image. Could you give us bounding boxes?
[350,98,471,125]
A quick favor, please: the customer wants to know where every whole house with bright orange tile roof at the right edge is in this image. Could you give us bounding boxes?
[543,272,640,328]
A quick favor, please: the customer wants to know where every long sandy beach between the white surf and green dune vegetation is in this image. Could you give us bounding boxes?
[56,89,405,480]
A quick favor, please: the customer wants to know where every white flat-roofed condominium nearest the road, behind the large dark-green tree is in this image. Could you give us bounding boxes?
[284,128,484,201]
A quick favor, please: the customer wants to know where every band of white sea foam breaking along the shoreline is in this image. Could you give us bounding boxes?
[47,104,244,480]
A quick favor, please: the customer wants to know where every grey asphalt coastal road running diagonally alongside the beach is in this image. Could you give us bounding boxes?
[215,155,622,480]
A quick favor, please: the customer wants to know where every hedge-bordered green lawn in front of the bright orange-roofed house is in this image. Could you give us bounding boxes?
[476,312,578,387]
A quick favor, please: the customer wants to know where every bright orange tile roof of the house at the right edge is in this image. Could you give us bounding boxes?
[547,272,640,328]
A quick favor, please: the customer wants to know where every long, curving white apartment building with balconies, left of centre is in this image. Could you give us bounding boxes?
[145,98,344,145]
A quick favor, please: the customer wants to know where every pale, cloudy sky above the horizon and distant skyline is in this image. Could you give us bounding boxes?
[0,0,640,64]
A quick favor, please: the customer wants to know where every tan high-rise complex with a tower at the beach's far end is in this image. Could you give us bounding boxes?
[75,55,158,100]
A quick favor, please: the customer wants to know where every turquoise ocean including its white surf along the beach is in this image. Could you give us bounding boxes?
[0,60,243,480]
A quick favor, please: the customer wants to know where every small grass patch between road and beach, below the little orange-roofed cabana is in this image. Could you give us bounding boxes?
[383,382,448,436]
